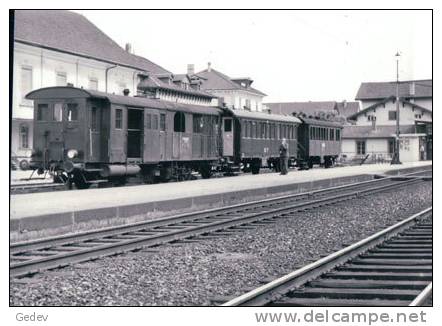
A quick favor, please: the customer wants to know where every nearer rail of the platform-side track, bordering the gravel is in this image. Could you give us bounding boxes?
[10,180,424,277]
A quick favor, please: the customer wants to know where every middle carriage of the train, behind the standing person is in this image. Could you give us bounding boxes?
[222,109,301,174]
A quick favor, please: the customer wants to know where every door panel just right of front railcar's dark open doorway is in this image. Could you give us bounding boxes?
[143,109,160,163]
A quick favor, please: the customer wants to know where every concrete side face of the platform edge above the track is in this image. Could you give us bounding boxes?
[10,167,432,234]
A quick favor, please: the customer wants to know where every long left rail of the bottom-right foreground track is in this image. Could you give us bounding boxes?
[222,207,433,306]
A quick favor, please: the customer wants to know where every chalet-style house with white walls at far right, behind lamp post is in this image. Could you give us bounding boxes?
[342,80,433,162]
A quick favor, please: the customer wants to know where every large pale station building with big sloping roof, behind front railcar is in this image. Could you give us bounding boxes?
[11,10,214,166]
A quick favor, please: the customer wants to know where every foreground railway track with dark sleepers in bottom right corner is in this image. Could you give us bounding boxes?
[223,207,433,306]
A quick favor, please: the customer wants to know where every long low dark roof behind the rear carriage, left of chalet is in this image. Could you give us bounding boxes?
[264,101,336,115]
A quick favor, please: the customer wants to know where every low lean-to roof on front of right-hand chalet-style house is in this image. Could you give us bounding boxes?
[342,125,416,139]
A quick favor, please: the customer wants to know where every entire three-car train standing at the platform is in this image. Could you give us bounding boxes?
[26,86,343,189]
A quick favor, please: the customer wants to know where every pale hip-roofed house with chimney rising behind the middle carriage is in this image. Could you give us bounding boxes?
[194,63,266,111]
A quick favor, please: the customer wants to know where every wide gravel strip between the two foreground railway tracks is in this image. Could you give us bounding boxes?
[10,182,432,306]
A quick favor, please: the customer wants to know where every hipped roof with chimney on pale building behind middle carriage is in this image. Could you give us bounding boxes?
[196,68,266,96]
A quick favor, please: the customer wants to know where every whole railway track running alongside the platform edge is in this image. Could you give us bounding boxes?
[10,171,432,277]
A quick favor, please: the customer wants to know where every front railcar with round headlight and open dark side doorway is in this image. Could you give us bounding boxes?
[26,87,221,188]
